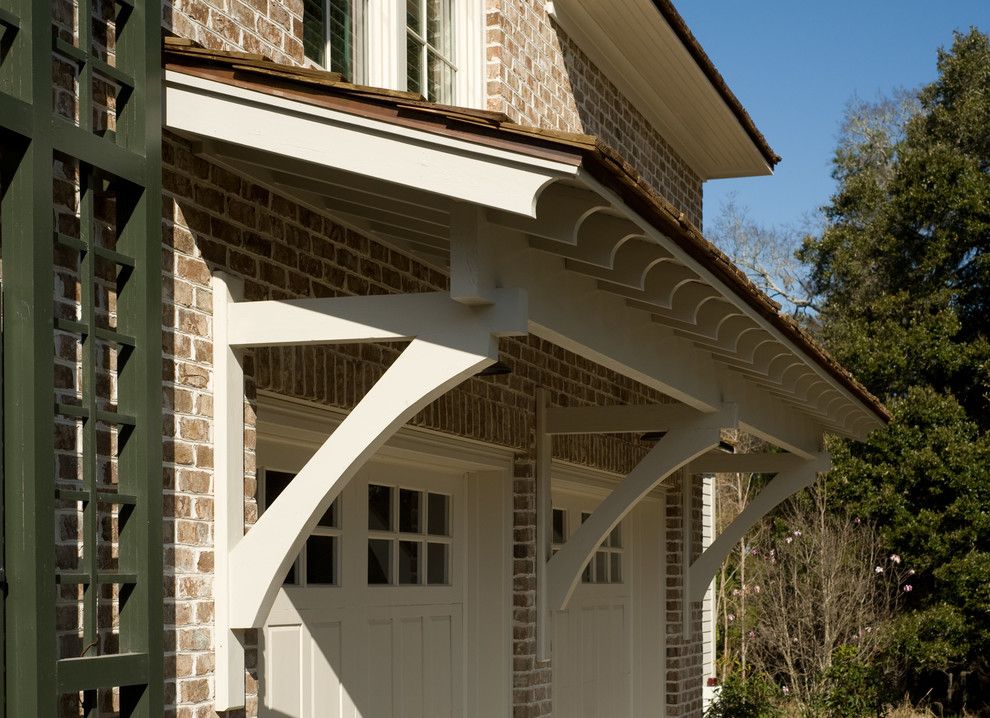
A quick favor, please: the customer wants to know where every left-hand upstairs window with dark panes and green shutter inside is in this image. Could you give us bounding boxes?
[303,0,367,83]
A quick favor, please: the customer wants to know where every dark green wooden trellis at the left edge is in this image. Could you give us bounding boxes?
[0,0,164,718]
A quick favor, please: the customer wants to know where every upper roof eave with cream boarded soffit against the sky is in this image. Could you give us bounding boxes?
[547,0,780,180]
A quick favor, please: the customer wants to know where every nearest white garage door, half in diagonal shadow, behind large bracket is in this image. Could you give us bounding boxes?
[260,464,465,718]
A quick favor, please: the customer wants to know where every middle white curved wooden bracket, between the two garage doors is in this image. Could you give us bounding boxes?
[537,404,738,630]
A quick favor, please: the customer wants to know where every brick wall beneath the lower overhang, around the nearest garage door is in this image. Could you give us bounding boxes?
[162,137,680,718]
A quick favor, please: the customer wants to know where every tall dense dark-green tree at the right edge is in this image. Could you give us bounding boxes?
[800,29,990,708]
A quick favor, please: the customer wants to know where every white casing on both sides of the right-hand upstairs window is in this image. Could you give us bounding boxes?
[365,0,487,109]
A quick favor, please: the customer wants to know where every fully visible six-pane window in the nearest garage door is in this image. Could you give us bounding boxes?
[368,484,451,586]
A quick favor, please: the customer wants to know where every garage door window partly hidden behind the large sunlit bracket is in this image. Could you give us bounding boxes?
[261,470,341,586]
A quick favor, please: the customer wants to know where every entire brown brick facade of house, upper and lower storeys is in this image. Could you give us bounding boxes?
[48,0,701,718]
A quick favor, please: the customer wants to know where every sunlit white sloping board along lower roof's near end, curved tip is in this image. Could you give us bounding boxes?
[165,70,576,217]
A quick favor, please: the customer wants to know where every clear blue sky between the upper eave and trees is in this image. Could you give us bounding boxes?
[675,0,990,232]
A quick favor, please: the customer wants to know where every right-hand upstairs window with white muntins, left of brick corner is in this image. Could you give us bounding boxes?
[406,0,457,104]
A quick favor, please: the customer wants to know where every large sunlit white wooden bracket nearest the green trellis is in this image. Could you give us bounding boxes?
[213,276,527,711]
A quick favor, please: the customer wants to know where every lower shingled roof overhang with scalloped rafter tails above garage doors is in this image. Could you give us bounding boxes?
[165,65,885,457]
